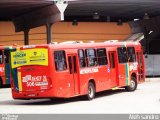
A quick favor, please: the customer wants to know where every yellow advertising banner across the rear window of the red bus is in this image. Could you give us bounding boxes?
[11,48,48,68]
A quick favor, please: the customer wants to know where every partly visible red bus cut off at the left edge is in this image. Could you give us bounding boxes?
[0,46,12,87]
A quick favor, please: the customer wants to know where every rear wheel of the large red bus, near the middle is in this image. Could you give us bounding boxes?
[87,82,96,100]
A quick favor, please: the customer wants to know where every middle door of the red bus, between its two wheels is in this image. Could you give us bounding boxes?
[109,51,118,87]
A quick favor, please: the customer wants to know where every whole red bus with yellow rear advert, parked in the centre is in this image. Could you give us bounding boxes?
[11,42,145,100]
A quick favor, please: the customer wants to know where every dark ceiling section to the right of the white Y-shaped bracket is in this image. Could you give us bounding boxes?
[65,0,160,22]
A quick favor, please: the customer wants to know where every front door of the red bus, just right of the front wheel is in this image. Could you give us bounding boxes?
[136,52,144,81]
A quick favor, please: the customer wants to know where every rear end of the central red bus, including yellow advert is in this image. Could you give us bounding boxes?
[11,47,53,99]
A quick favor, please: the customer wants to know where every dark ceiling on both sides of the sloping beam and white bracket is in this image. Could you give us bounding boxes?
[0,0,160,21]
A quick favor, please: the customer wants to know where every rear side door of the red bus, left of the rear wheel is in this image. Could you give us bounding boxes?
[68,54,79,96]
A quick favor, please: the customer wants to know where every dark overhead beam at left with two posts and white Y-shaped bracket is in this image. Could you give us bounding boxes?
[0,0,68,45]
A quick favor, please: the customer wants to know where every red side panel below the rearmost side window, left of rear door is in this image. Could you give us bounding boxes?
[48,49,70,98]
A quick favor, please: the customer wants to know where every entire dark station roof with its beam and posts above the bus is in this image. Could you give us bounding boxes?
[0,0,160,48]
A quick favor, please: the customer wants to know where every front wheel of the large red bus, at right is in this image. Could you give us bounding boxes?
[125,77,137,92]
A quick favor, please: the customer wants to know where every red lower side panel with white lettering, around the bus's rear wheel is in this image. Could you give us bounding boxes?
[80,66,110,95]
